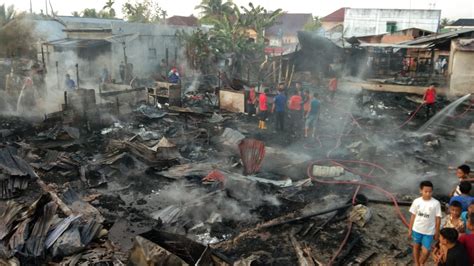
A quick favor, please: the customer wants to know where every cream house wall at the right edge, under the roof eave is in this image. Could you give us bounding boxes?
[448,42,474,95]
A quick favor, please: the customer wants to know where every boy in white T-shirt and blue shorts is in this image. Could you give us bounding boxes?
[408,181,441,266]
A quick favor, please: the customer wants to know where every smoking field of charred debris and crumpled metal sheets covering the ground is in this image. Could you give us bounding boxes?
[0,71,474,265]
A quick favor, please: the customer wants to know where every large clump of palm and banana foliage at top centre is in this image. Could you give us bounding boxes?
[180,0,281,76]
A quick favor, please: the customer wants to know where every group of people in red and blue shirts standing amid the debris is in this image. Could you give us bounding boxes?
[247,78,337,138]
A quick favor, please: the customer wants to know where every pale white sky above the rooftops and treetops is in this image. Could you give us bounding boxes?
[0,0,474,20]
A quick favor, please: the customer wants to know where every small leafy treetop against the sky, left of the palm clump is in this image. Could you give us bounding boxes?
[122,0,166,23]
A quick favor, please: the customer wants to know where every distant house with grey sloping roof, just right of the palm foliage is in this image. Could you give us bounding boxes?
[265,13,313,49]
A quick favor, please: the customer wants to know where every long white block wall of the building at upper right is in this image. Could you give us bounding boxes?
[344,8,441,38]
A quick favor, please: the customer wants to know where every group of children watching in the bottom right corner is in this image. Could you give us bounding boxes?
[408,165,474,266]
